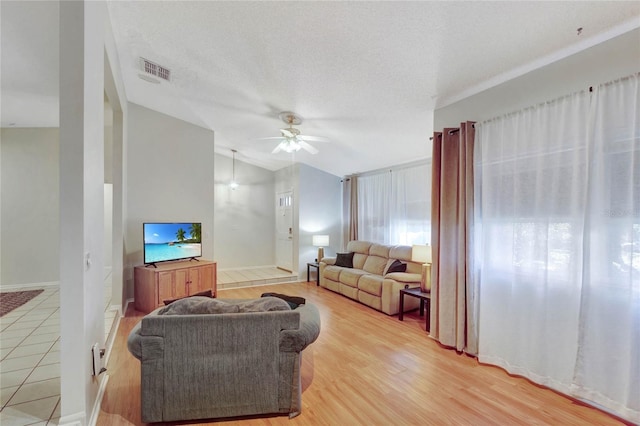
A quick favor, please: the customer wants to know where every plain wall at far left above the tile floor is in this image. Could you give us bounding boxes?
[0,128,60,287]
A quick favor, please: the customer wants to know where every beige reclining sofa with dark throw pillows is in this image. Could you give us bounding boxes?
[320,241,430,315]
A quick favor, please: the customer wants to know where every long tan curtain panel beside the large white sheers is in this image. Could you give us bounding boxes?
[430,122,478,355]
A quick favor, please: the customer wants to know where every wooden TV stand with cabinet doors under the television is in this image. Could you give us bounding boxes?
[133,260,217,313]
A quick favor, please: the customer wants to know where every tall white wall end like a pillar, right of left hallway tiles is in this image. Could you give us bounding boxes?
[59,2,108,424]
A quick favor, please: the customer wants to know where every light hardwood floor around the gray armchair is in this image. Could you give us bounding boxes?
[97,282,626,426]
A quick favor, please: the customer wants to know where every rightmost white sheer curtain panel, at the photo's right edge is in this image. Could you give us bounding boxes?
[573,74,640,423]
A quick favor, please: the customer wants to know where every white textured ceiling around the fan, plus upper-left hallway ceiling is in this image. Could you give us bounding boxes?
[0,0,640,176]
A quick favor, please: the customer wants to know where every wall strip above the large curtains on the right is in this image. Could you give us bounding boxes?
[434,29,640,131]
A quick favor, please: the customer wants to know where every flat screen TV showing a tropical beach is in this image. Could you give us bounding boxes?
[142,222,202,266]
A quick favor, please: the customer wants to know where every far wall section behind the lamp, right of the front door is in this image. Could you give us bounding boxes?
[298,164,342,280]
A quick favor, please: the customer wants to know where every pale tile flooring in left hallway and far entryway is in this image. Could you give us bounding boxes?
[0,267,297,426]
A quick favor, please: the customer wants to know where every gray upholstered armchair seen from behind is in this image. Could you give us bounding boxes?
[128,299,320,422]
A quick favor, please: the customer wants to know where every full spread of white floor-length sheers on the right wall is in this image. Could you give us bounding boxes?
[475,75,640,421]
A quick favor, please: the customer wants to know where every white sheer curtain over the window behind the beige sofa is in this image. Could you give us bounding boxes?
[357,163,431,245]
